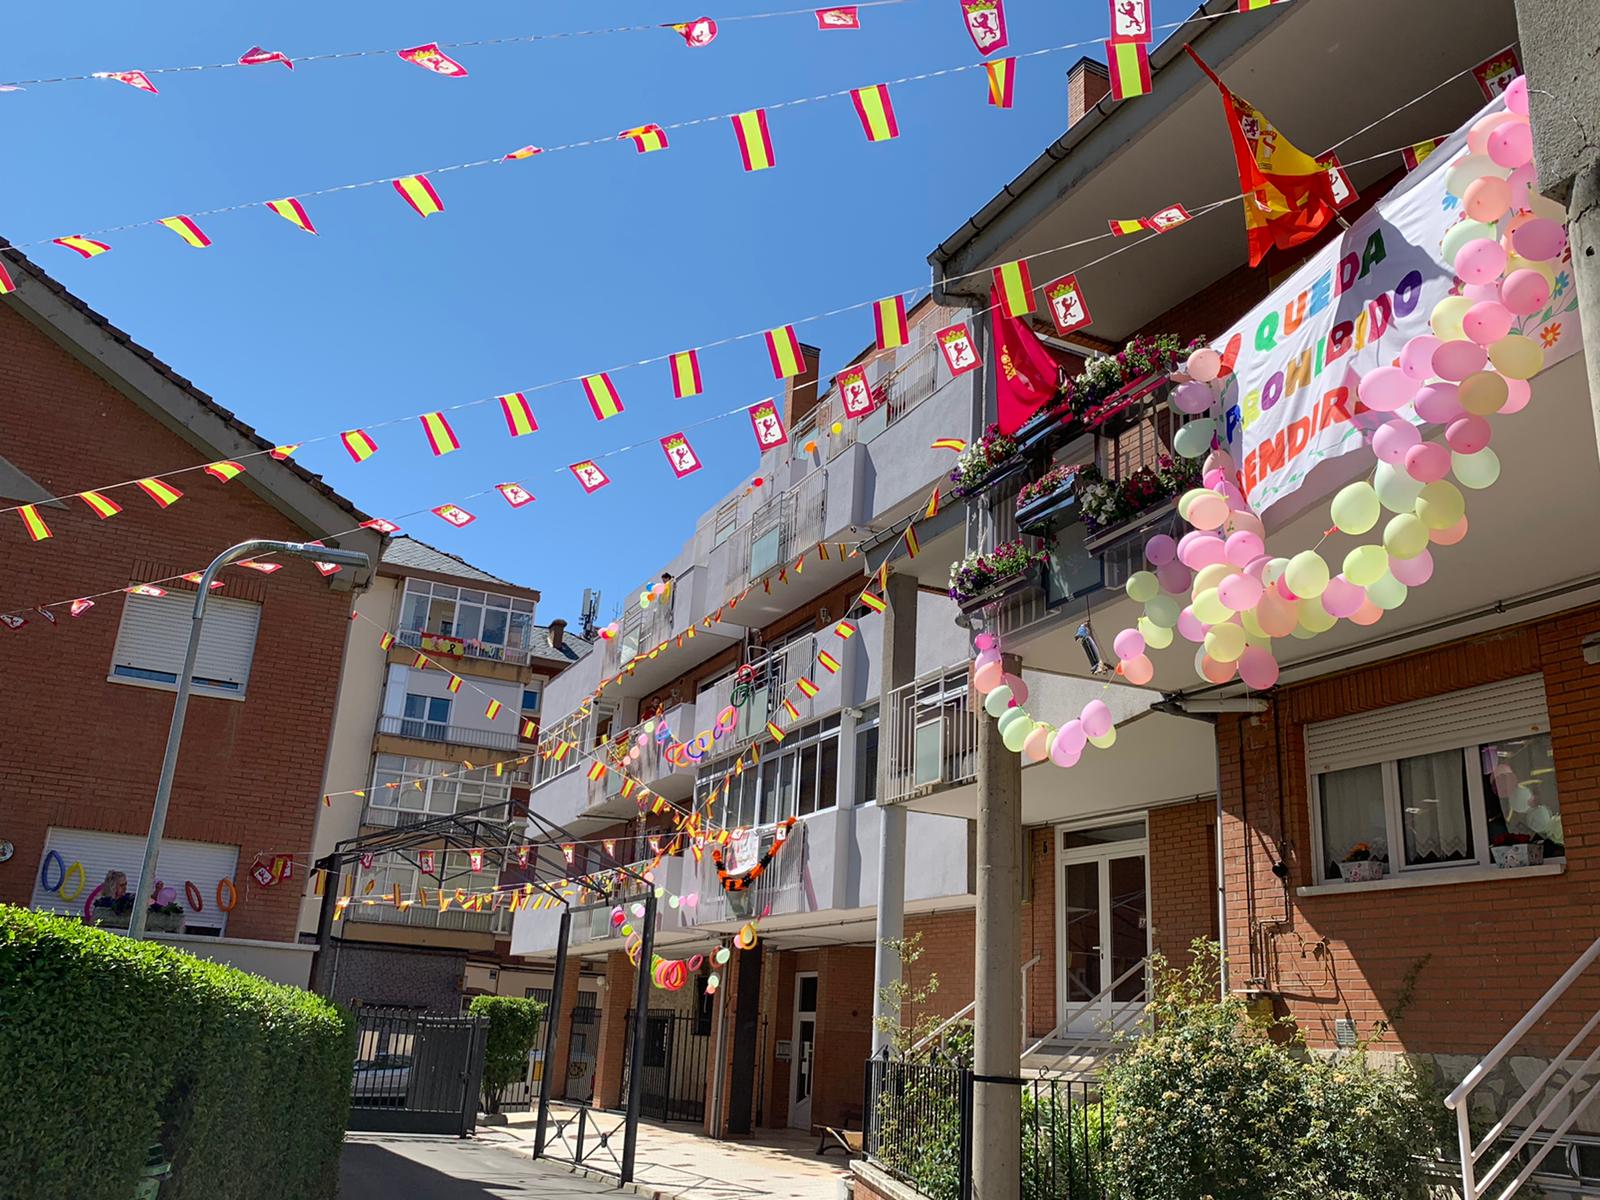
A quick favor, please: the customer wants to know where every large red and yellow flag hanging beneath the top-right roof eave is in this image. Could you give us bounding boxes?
[1184,46,1338,266]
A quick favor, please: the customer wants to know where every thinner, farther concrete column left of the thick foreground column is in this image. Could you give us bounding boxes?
[872,574,917,1054]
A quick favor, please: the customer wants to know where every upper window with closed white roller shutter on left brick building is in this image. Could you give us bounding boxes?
[110,592,261,696]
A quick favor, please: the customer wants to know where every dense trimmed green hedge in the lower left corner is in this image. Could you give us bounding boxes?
[0,906,354,1200]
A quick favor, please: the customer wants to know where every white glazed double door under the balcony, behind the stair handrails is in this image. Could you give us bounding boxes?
[1056,818,1150,1034]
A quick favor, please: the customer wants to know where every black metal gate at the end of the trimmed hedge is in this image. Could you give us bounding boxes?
[349,1008,488,1138]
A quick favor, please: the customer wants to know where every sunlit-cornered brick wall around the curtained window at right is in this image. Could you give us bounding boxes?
[1218,606,1600,1054]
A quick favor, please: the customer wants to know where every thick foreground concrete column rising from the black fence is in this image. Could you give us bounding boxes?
[973,656,1022,1200]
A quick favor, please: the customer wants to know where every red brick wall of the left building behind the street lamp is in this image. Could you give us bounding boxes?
[0,300,350,941]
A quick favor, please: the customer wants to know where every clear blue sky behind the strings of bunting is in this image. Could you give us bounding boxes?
[0,0,1187,621]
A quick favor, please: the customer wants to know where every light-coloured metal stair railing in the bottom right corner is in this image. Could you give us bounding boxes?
[1445,939,1600,1200]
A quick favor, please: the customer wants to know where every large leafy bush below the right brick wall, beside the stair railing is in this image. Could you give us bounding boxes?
[1104,941,1435,1200]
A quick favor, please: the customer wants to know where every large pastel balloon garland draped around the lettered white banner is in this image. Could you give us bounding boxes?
[1112,78,1566,690]
